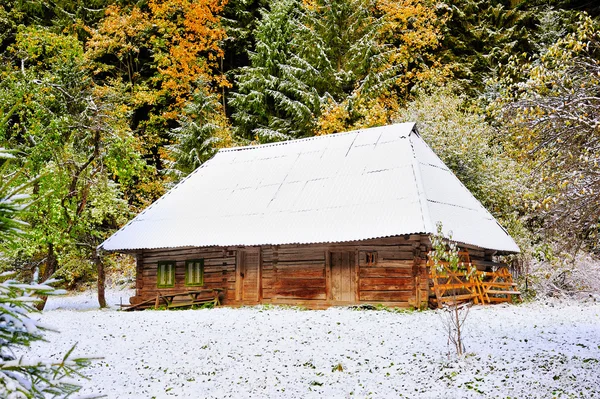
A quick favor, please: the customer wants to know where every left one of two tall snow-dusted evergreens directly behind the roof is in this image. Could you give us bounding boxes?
[230,0,320,141]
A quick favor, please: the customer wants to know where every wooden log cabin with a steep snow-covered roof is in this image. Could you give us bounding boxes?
[100,123,519,308]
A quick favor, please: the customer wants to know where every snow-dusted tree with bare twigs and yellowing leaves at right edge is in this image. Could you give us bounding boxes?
[503,15,600,250]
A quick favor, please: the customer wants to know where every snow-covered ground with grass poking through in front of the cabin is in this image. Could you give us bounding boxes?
[32,291,600,398]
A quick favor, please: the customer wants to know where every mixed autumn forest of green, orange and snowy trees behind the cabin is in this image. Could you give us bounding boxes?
[0,0,600,308]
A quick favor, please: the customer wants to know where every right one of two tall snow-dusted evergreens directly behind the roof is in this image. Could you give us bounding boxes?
[292,0,395,115]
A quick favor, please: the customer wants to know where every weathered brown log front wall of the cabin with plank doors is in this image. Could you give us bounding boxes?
[131,235,502,308]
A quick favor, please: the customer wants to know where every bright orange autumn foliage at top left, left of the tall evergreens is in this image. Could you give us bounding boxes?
[87,0,227,120]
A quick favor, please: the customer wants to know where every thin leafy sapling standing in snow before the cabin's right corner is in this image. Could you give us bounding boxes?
[428,222,476,356]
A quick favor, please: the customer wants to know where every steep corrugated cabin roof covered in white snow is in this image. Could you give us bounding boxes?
[101,123,519,252]
